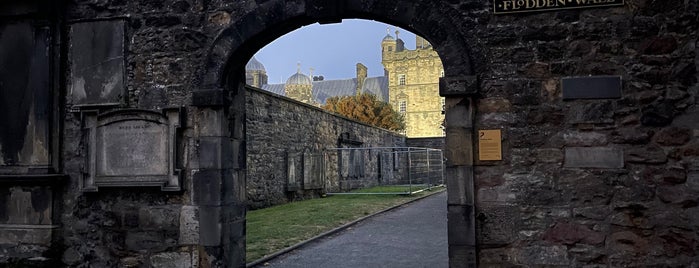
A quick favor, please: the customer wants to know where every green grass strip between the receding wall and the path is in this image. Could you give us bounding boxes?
[246,188,443,262]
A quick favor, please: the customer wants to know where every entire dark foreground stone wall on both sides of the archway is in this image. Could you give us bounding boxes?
[0,0,699,267]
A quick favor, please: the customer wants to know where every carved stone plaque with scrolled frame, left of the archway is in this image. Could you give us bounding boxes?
[81,109,181,192]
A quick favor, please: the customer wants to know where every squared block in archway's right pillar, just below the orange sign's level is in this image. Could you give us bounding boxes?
[446,166,474,205]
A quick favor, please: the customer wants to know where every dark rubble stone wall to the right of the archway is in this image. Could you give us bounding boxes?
[468,1,699,267]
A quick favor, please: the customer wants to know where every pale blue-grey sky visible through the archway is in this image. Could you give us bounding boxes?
[255,19,415,84]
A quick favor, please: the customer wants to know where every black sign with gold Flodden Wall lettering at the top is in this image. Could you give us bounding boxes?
[493,0,624,14]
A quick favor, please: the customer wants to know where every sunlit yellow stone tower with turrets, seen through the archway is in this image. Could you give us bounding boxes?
[381,31,444,138]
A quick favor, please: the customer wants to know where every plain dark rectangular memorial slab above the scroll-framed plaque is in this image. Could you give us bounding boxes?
[68,20,125,107]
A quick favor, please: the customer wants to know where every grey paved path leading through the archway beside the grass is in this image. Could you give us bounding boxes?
[264,191,449,268]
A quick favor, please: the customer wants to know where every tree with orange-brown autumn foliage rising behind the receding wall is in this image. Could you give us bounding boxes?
[323,93,405,131]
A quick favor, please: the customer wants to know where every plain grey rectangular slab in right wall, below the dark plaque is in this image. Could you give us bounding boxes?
[564,147,624,168]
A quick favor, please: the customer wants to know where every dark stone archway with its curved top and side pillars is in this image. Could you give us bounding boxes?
[192,0,477,267]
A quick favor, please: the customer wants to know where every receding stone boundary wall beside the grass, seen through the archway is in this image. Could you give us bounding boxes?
[245,87,405,208]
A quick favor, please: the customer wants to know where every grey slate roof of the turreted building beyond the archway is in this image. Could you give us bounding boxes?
[262,76,388,104]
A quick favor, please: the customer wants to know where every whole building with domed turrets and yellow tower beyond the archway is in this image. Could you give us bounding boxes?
[246,31,444,138]
